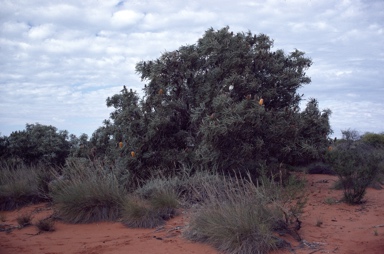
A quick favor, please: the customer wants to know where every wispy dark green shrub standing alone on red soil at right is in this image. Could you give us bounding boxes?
[328,141,382,204]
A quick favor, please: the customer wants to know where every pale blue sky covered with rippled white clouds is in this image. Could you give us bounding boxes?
[0,0,384,139]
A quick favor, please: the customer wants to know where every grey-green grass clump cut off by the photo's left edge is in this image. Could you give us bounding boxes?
[0,164,42,211]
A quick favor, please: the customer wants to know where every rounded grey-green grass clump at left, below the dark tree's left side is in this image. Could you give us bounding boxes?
[52,164,124,223]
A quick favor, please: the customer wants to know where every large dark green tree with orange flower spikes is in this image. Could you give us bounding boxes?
[91,27,331,179]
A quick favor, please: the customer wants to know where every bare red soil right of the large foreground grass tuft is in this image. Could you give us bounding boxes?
[274,175,384,254]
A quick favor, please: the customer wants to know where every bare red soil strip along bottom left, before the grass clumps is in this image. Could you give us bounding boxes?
[0,204,217,254]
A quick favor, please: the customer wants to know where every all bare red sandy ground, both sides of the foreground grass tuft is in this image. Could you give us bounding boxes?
[0,175,384,254]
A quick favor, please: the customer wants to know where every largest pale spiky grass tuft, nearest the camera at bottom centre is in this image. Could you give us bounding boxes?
[185,175,303,254]
